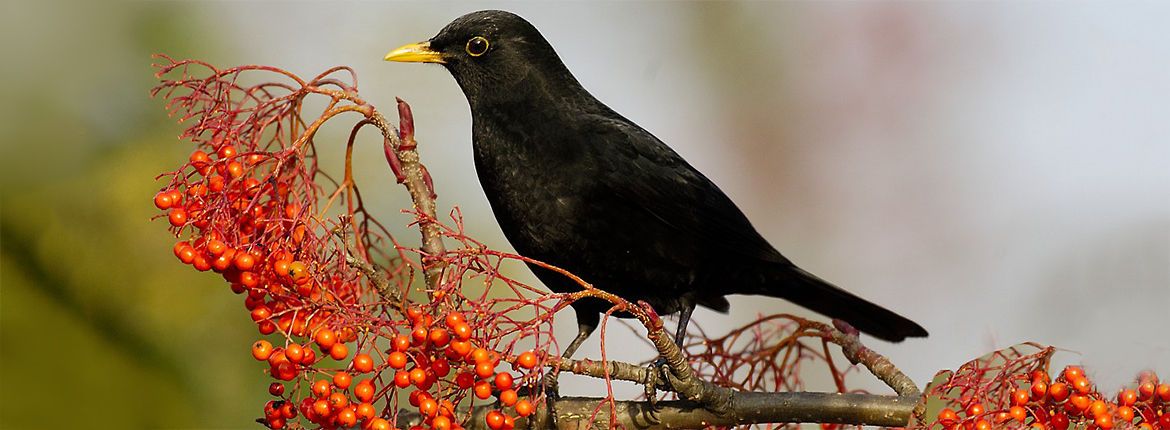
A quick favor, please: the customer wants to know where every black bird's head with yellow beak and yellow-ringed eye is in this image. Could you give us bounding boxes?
[385,11,579,105]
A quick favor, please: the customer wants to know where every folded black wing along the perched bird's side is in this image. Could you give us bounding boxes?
[589,117,791,265]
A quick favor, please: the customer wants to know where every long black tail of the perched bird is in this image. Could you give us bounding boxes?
[758,265,927,342]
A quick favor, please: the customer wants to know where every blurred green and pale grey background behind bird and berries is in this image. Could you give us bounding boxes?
[0,0,1170,429]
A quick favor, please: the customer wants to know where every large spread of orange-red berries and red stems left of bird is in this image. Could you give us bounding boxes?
[153,57,551,430]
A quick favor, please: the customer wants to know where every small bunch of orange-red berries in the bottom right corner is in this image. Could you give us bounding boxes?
[937,366,1170,430]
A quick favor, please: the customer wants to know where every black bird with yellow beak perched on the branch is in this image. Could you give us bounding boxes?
[385,11,927,356]
